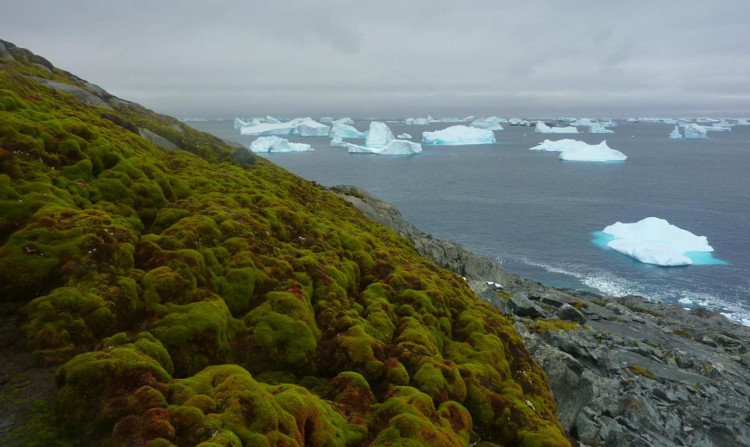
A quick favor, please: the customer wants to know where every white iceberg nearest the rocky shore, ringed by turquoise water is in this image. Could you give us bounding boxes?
[603,217,714,267]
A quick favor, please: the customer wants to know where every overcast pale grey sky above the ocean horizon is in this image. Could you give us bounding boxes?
[0,0,750,118]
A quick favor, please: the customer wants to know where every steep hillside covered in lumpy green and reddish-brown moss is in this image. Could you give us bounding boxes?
[0,46,568,446]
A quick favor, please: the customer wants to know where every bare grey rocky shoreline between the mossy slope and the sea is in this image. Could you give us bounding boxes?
[331,186,750,447]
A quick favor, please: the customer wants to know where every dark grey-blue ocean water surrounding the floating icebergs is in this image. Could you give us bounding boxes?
[189,117,750,324]
